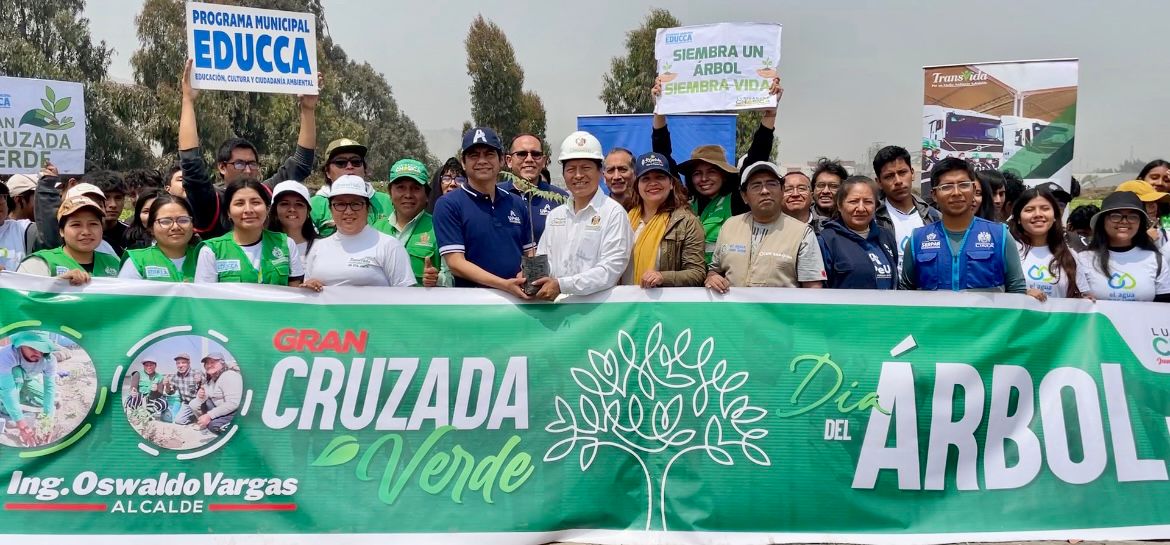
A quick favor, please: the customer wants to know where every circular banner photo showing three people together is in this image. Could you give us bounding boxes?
[122,334,243,450]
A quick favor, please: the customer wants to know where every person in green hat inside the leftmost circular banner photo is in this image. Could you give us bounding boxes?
[0,331,57,447]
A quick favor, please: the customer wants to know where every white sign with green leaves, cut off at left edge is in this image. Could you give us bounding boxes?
[0,76,85,174]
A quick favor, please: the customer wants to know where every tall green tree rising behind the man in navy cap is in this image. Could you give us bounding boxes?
[463,15,546,144]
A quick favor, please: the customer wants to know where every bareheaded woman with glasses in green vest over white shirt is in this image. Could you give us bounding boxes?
[118,193,199,282]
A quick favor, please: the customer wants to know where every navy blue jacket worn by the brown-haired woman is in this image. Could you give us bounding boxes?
[817,220,897,290]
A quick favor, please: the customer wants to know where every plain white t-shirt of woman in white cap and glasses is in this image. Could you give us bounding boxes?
[305,226,414,287]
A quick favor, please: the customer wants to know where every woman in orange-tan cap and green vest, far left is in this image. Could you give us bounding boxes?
[16,195,119,280]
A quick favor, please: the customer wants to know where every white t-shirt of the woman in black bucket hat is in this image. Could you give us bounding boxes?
[1076,248,1170,301]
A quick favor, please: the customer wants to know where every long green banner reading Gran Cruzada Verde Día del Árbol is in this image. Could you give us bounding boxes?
[0,277,1170,545]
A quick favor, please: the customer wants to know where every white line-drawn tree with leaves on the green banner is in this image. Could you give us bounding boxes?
[544,323,772,530]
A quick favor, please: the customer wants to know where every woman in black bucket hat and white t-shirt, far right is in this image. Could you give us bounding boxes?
[1076,191,1170,303]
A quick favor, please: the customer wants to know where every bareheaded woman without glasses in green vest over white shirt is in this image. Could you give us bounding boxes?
[195,179,304,287]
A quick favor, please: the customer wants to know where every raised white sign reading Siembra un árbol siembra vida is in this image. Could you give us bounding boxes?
[654,22,780,113]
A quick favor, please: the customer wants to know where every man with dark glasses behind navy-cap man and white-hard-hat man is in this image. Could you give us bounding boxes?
[500,133,569,241]
